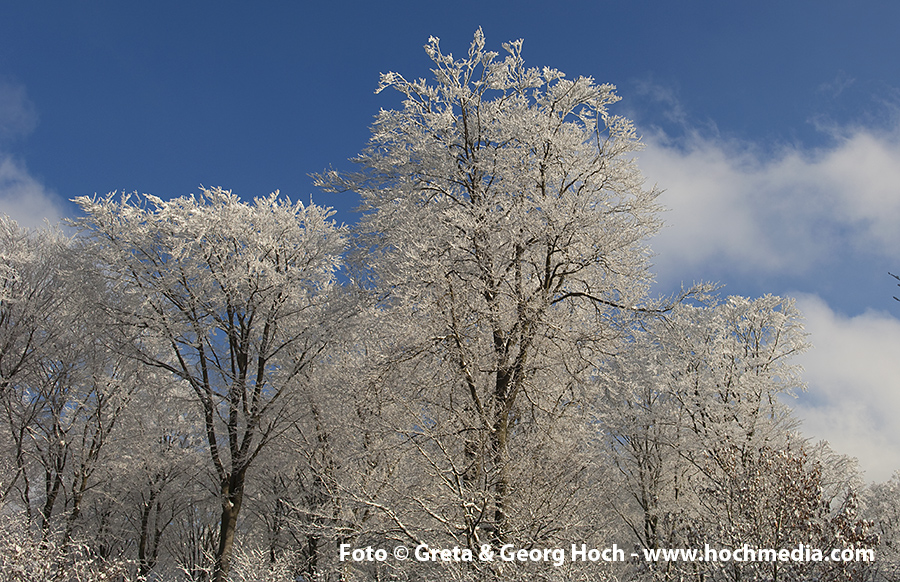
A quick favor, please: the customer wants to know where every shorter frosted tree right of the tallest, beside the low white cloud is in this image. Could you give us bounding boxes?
[598,296,807,548]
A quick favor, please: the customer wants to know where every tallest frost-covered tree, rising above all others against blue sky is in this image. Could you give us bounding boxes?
[318,30,672,560]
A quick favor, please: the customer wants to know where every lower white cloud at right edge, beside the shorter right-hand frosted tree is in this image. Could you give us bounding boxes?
[789,295,900,481]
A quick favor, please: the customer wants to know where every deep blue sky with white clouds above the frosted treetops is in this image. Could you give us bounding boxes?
[0,0,900,480]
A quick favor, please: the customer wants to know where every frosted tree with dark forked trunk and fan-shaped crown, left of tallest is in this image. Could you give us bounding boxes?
[77,189,344,582]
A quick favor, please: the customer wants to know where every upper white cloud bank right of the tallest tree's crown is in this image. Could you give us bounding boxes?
[639,129,900,278]
